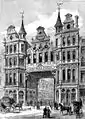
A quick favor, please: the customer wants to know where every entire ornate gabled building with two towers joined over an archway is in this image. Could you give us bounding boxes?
[4,7,85,103]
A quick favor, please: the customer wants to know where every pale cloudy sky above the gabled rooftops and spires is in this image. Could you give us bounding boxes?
[0,0,85,45]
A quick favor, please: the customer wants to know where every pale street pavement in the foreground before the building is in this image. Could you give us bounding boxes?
[0,106,85,119]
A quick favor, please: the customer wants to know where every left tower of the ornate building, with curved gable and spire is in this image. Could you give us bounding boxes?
[4,17,27,102]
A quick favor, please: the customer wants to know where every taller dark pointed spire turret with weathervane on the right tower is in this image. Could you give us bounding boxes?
[54,3,63,33]
